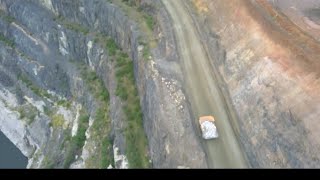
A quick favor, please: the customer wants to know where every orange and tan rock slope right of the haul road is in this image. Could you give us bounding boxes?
[189,0,320,168]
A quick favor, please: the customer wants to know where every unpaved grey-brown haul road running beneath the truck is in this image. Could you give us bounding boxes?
[162,0,247,168]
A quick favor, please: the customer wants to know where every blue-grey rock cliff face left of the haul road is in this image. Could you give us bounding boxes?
[0,0,207,168]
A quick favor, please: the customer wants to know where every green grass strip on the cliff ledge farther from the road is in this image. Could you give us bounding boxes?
[72,62,117,168]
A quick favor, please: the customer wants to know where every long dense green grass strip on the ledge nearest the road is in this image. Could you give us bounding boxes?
[115,43,149,168]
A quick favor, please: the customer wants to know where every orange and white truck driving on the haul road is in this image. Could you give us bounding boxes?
[199,116,219,140]
